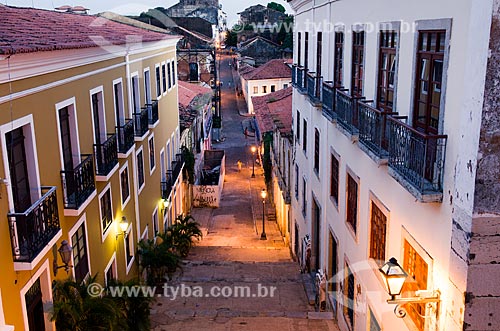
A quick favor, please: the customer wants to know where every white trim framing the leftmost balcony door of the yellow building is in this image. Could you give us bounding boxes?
[0,114,41,212]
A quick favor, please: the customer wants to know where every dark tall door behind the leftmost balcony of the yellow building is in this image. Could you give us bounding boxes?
[6,127,31,212]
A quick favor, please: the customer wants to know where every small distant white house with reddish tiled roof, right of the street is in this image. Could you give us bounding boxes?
[240,59,292,114]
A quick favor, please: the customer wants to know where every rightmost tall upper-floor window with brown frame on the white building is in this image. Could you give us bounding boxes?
[413,30,446,134]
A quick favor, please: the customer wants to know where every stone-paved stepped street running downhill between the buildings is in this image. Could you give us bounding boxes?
[151,57,338,331]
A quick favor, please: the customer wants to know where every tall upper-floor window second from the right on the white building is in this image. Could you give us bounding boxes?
[377,31,398,112]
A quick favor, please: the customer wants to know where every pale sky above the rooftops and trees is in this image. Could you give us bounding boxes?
[0,0,292,27]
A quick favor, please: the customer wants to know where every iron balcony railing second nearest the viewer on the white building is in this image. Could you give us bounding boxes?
[358,100,397,159]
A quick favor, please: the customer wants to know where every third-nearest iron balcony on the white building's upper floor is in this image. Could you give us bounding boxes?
[335,89,362,135]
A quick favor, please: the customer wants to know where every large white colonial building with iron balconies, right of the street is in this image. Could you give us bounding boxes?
[289,0,500,331]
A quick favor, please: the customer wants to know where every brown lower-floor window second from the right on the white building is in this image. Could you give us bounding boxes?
[370,201,387,266]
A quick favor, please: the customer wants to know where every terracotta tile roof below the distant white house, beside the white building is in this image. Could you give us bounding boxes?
[252,87,293,134]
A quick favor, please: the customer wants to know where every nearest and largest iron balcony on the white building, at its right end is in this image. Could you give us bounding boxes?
[387,116,447,202]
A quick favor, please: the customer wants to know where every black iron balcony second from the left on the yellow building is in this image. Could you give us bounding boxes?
[61,155,95,210]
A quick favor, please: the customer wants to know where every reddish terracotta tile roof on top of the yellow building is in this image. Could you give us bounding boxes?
[0,5,177,54]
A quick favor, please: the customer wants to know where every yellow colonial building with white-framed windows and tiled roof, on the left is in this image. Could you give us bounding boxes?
[0,5,184,331]
